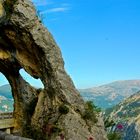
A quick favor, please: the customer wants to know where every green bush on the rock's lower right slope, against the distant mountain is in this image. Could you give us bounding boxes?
[82,101,101,123]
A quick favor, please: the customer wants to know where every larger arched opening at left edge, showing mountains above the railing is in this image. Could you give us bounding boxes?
[0,73,14,112]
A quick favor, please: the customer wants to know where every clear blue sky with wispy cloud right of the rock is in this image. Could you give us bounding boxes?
[0,0,140,88]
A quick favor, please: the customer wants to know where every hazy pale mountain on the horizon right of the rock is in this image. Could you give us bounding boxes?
[79,80,140,109]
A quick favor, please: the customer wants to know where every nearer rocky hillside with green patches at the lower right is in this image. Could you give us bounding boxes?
[105,91,140,140]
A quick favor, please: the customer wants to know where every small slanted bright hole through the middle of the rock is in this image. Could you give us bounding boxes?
[19,69,44,88]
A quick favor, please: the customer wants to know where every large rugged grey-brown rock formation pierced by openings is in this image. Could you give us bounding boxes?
[0,0,106,140]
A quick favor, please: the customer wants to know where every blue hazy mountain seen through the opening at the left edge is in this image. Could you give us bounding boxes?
[0,84,12,99]
